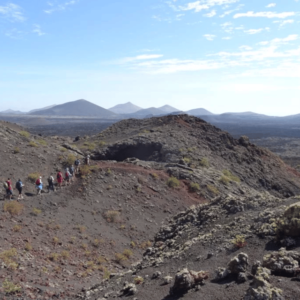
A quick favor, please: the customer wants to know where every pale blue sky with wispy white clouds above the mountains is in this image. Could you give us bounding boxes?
[0,0,300,116]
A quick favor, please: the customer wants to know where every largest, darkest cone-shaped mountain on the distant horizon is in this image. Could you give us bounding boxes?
[29,99,117,118]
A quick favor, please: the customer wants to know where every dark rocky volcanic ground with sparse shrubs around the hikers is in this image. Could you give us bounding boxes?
[0,116,300,300]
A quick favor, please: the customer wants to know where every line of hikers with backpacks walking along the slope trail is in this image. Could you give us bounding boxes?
[4,155,90,201]
